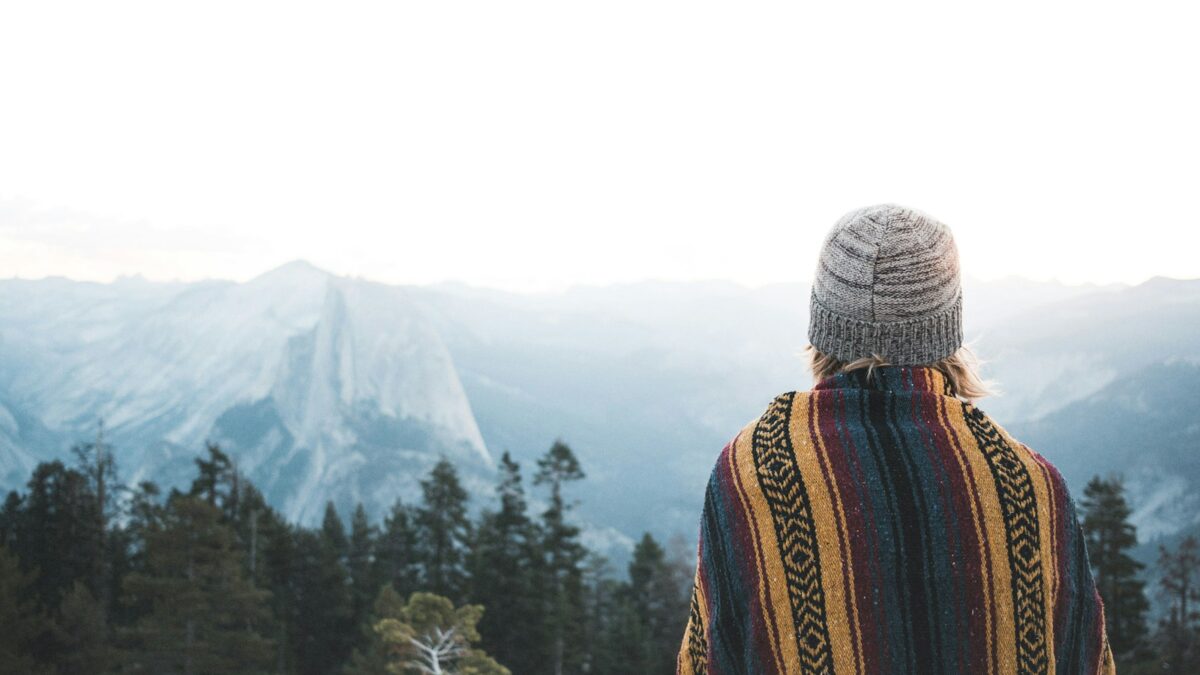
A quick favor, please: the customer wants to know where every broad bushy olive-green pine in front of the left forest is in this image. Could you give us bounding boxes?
[114,492,271,673]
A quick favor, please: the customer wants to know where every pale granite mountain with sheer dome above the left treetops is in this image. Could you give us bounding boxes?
[0,262,492,524]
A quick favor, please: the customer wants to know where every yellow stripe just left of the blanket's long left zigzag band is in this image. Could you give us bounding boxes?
[730,420,800,673]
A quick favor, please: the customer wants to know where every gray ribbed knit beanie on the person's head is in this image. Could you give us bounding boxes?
[809,204,962,365]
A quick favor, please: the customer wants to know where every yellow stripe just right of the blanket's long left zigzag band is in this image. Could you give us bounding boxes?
[788,393,862,673]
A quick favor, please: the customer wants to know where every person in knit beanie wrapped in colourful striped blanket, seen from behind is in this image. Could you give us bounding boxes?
[677,204,1115,675]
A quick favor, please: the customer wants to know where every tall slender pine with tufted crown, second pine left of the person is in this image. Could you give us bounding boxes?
[534,440,587,675]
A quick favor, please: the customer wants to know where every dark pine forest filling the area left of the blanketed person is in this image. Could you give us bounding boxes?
[0,438,695,675]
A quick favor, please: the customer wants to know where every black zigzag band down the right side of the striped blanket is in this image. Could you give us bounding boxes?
[964,404,1050,674]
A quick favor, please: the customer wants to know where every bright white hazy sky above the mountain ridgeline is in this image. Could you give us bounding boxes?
[0,0,1200,289]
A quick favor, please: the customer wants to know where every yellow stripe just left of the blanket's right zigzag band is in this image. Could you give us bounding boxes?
[947,410,1016,673]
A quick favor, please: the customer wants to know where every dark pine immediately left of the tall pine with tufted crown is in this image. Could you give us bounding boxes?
[469,452,545,673]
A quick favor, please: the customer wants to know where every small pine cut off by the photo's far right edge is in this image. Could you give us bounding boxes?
[1156,536,1200,675]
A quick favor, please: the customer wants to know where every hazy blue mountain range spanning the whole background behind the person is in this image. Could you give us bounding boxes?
[0,263,1200,561]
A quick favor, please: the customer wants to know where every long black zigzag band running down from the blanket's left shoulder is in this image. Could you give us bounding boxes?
[752,392,833,673]
